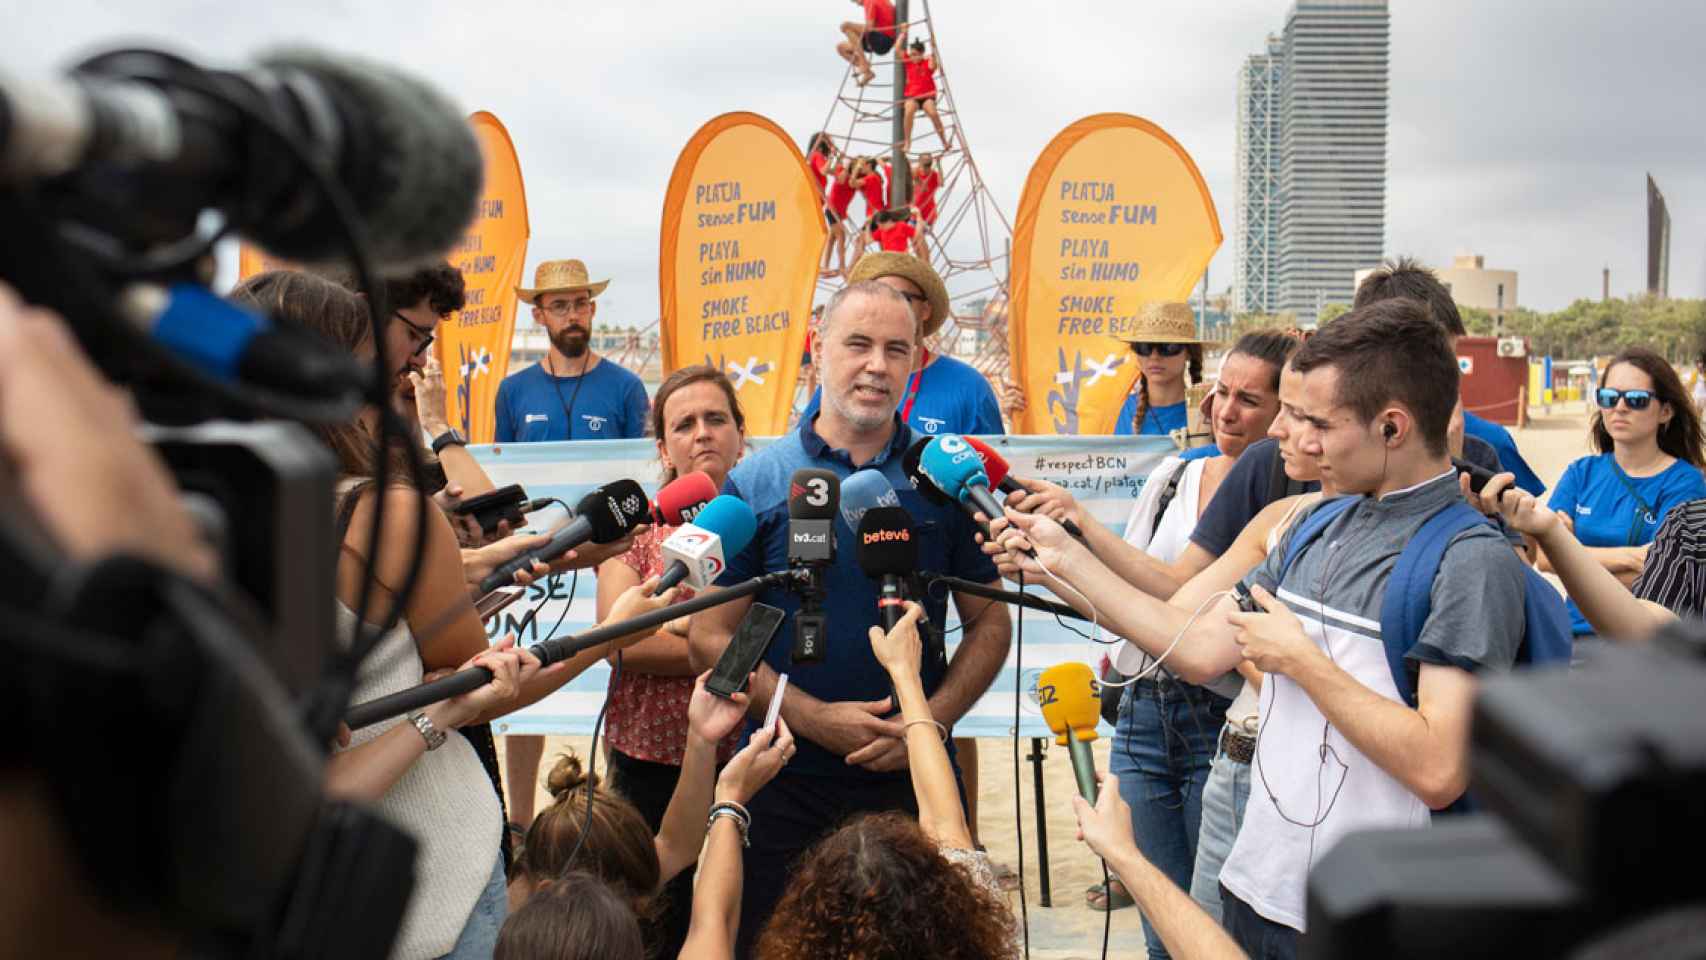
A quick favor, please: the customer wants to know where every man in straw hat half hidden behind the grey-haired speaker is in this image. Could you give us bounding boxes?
[800,251,1005,437]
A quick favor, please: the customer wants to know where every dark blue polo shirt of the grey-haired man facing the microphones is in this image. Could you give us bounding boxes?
[717,414,998,779]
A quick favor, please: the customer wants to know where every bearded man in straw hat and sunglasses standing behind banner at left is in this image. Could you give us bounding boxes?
[496,259,648,443]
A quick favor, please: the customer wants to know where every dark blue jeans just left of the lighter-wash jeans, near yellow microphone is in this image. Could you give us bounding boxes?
[1109,679,1232,960]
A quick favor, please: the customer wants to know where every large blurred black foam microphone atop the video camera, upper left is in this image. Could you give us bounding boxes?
[0,49,483,266]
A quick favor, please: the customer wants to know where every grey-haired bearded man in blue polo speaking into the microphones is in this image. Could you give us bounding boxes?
[689,281,1010,957]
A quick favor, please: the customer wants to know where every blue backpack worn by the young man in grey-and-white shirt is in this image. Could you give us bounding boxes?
[1281,496,1575,709]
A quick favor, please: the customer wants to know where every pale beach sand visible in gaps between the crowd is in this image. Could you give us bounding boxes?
[500,402,1588,960]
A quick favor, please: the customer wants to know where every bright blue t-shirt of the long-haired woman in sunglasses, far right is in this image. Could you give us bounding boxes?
[1547,454,1706,636]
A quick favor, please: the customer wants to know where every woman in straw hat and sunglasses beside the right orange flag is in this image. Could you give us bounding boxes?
[1114,302,1204,437]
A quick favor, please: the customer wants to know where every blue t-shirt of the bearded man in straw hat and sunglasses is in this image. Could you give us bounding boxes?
[495,358,650,443]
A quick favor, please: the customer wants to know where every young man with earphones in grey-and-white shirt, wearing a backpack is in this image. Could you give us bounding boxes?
[993,300,1525,957]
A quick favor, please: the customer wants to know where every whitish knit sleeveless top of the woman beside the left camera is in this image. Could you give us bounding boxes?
[338,602,503,960]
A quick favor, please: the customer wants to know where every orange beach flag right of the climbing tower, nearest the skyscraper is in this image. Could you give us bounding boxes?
[1008,113,1221,435]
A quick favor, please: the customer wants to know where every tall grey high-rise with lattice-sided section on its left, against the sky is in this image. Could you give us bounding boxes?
[1237,0,1390,322]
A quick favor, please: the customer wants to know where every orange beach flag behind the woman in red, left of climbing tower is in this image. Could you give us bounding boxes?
[659,113,827,437]
